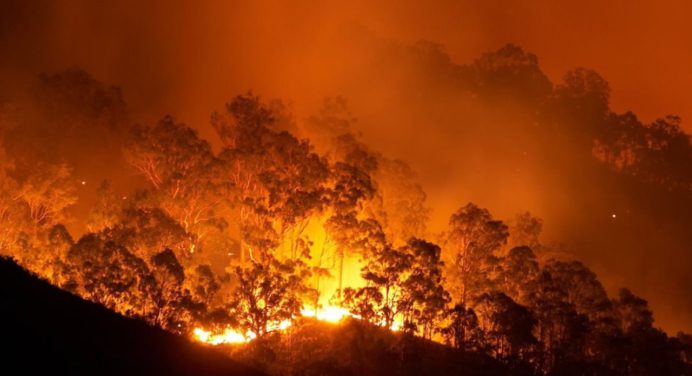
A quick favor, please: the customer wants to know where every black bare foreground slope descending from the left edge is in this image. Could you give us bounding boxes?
[0,258,261,376]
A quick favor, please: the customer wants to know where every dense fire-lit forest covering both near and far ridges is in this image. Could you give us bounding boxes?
[0,45,692,375]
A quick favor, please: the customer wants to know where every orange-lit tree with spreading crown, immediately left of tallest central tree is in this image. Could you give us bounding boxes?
[126,116,230,254]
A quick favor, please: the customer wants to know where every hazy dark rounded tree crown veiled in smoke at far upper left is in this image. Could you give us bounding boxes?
[7,68,129,173]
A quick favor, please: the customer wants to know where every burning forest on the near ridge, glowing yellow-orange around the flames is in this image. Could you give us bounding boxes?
[0,81,688,372]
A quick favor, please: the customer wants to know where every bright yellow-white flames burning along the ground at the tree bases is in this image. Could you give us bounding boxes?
[192,306,400,345]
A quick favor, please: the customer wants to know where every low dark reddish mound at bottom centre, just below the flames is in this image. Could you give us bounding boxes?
[228,319,512,376]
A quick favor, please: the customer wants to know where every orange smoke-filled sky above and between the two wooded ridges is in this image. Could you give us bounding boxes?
[0,0,692,331]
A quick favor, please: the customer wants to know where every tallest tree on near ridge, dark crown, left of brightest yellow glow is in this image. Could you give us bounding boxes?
[212,93,329,263]
